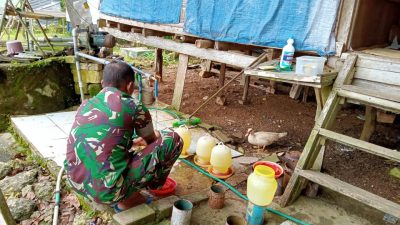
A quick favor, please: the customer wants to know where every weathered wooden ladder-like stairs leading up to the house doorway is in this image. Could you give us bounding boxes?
[280,54,400,218]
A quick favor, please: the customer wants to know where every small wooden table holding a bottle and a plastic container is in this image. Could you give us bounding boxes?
[242,60,338,118]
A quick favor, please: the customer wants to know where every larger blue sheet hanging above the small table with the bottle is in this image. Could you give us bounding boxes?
[184,0,340,55]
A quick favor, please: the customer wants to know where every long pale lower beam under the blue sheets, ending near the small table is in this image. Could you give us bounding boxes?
[103,27,256,68]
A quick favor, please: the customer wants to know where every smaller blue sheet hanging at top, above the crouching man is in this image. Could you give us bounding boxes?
[100,0,182,24]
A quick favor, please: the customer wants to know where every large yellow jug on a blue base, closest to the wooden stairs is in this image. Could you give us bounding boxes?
[247,165,278,206]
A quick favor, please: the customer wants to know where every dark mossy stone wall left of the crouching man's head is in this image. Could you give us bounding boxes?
[0,57,79,130]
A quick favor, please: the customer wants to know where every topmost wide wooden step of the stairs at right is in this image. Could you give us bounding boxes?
[337,85,400,113]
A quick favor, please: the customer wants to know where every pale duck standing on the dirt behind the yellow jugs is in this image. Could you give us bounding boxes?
[245,128,287,150]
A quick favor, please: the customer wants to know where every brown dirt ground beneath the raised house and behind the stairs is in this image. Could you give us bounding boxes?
[159,64,400,202]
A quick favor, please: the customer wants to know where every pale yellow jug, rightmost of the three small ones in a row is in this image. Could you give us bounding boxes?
[210,143,232,174]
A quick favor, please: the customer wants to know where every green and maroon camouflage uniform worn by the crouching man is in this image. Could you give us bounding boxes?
[64,87,182,204]
